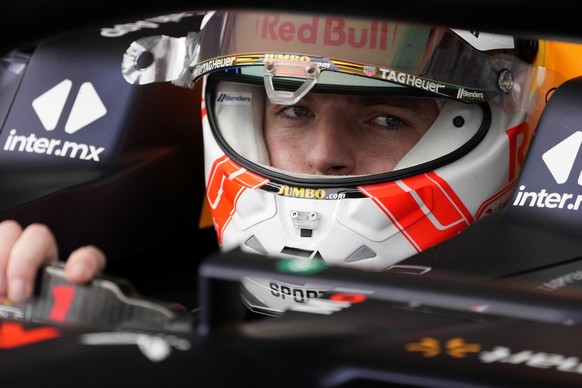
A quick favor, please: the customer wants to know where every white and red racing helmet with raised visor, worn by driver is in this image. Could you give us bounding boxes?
[122,11,543,311]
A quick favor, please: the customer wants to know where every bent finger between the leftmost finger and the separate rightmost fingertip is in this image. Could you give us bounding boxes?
[6,224,58,303]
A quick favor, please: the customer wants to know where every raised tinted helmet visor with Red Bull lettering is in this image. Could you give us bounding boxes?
[190,12,529,107]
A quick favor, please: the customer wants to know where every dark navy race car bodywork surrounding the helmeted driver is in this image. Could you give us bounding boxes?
[0,1,582,387]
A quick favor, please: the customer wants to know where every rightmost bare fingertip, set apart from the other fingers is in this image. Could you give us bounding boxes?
[65,245,107,283]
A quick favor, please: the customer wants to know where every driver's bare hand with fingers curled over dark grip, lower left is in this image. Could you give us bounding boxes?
[0,220,106,303]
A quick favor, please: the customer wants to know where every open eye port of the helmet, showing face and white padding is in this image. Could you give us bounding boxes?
[205,72,490,183]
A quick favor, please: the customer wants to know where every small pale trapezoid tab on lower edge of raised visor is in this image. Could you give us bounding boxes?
[264,60,320,105]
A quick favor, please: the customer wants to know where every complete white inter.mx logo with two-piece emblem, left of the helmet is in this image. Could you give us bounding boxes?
[3,79,107,162]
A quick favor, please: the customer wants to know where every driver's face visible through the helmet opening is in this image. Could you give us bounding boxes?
[265,93,439,175]
